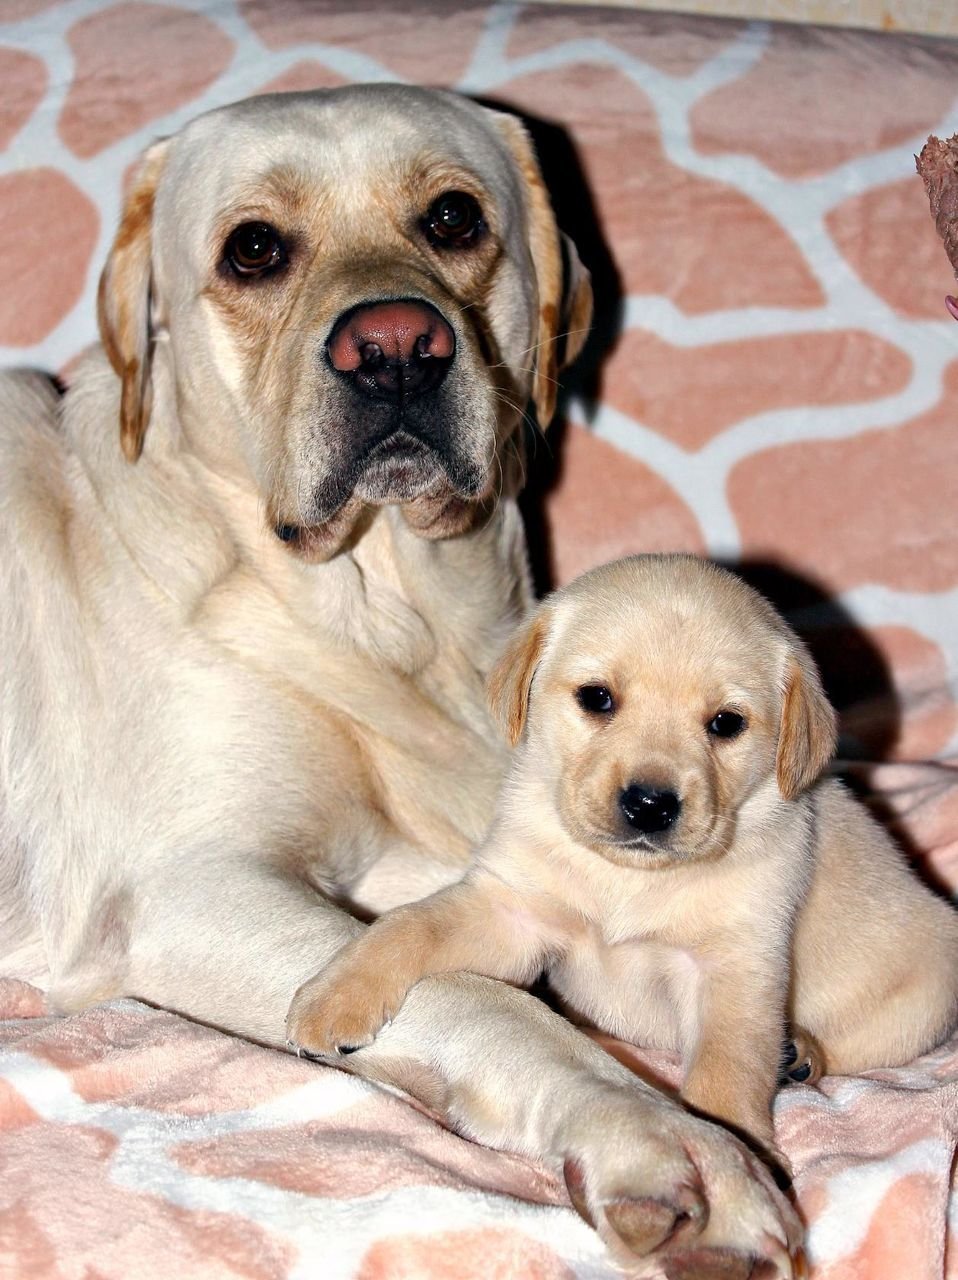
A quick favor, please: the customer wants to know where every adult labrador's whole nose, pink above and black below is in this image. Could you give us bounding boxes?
[327,298,456,406]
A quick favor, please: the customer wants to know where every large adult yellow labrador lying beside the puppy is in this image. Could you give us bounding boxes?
[0,86,798,1277]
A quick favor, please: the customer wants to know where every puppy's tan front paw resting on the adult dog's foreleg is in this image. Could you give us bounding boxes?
[286,960,402,1057]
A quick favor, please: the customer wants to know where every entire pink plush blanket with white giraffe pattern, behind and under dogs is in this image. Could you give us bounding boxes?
[0,0,958,1280]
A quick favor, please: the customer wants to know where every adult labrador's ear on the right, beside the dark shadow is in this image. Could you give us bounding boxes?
[492,111,592,430]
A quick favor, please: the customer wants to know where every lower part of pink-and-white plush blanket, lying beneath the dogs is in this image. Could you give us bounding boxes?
[0,979,958,1280]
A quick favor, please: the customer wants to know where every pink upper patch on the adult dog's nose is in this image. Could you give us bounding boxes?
[327,302,456,374]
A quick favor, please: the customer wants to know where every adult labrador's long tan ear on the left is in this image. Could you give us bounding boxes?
[97,141,168,462]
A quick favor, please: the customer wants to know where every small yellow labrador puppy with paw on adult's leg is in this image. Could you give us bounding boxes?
[293,556,958,1147]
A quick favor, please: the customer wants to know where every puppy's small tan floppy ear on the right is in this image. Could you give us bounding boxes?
[775,650,836,800]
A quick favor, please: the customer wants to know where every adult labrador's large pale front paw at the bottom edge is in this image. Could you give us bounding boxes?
[565,1093,804,1280]
